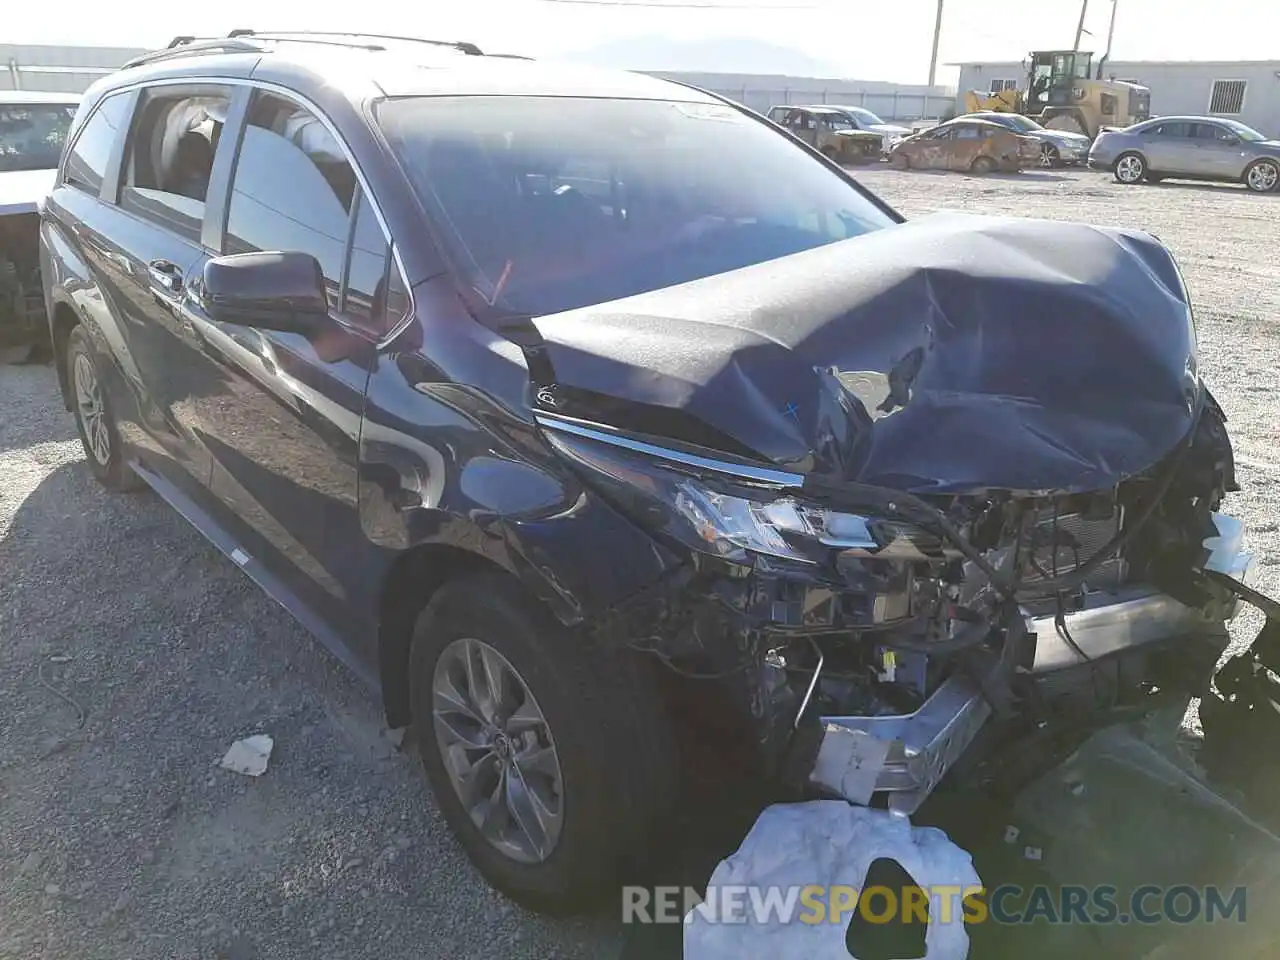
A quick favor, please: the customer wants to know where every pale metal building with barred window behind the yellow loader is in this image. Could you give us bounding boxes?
[955,60,1280,137]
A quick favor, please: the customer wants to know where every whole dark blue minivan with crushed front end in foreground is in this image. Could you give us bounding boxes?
[41,31,1271,911]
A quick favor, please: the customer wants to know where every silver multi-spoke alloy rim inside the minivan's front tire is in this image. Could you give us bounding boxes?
[431,637,564,863]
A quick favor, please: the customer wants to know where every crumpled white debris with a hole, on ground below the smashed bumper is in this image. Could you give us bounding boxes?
[684,800,982,960]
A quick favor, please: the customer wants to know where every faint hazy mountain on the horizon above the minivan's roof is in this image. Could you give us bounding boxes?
[558,37,845,77]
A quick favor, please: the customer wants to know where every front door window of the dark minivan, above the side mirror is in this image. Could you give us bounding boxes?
[223,91,358,307]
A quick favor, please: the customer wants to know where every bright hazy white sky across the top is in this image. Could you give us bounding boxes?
[0,0,1280,83]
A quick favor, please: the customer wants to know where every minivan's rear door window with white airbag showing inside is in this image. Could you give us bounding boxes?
[120,87,230,241]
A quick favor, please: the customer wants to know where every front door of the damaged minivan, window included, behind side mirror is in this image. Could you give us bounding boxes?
[179,91,404,660]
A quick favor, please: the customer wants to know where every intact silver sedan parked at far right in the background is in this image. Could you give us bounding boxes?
[1089,116,1280,193]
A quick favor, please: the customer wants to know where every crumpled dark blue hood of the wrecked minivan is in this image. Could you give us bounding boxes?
[534,215,1201,493]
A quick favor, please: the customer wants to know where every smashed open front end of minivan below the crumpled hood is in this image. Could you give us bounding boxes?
[554,394,1252,813]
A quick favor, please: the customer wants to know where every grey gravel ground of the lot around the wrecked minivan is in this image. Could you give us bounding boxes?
[0,169,1280,960]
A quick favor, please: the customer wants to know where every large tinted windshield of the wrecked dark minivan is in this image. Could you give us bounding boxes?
[378,96,893,316]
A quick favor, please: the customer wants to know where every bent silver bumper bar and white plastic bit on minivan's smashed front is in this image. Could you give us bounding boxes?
[809,513,1254,814]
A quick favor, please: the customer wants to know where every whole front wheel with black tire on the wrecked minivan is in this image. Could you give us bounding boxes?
[410,575,680,915]
